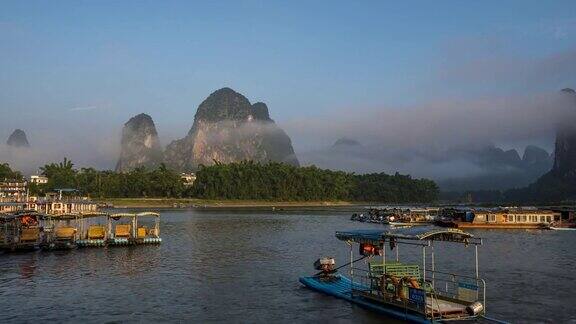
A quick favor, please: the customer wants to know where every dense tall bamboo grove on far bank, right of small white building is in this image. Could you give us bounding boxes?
[192,162,438,203]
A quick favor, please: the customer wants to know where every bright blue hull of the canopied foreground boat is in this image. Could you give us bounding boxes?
[300,275,432,323]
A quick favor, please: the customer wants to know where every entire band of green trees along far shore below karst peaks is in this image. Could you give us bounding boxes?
[3,159,439,207]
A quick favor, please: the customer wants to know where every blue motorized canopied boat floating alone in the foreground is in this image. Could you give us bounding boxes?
[300,226,500,323]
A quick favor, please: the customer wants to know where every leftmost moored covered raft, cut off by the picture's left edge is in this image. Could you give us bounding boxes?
[0,211,45,252]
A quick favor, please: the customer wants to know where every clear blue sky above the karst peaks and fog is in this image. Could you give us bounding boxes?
[0,1,576,170]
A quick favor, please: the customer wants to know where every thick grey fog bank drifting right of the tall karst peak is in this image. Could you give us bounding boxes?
[291,91,576,190]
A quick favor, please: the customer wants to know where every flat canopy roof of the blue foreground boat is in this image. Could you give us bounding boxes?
[336,226,474,244]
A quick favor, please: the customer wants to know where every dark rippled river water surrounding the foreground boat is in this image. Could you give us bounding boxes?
[0,210,576,323]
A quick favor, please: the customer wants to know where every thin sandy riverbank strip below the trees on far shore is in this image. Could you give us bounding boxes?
[94,198,363,208]
